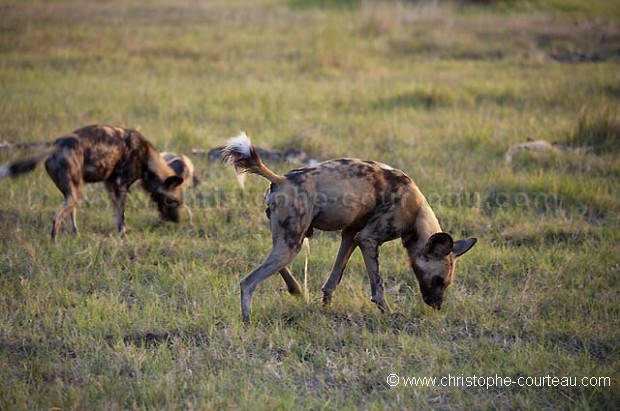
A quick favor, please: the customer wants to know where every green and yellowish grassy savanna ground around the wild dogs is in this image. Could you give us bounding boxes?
[0,0,620,410]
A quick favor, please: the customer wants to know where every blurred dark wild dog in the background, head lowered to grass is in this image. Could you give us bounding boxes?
[0,125,183,241]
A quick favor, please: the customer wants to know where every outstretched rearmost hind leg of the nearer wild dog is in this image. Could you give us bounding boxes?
[240,241,301,323]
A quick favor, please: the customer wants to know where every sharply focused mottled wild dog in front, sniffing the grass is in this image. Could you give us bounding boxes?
[222,133,476,322]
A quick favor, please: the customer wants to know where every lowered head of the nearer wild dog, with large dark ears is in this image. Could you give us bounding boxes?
[411,233,477,310]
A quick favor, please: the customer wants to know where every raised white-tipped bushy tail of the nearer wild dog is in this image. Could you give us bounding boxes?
[221,131,285,187]
